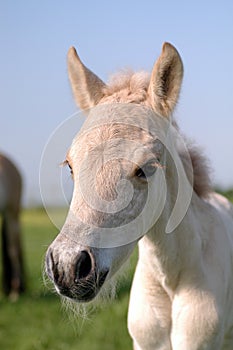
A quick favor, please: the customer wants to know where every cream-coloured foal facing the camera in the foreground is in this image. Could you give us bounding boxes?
[46,43,233,350]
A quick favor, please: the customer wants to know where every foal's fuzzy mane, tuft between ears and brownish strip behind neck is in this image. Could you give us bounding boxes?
[101,71,211,198]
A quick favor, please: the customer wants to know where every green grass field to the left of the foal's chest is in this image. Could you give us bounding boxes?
[0,210,136,350]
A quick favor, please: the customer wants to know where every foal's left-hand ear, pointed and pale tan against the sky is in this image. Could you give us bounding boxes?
[67,47,105,110]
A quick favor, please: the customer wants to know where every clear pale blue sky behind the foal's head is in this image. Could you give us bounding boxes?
[0,0,233,203]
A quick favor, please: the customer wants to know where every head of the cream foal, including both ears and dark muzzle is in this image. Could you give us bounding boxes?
[46,43,183,301]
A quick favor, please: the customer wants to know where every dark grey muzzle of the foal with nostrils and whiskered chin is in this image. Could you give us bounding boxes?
[46,248,108,302]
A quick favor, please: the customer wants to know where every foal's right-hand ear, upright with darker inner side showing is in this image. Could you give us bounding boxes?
[148,43,183,117]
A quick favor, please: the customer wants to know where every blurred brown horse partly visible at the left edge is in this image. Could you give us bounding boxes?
[0,154,25,299]
